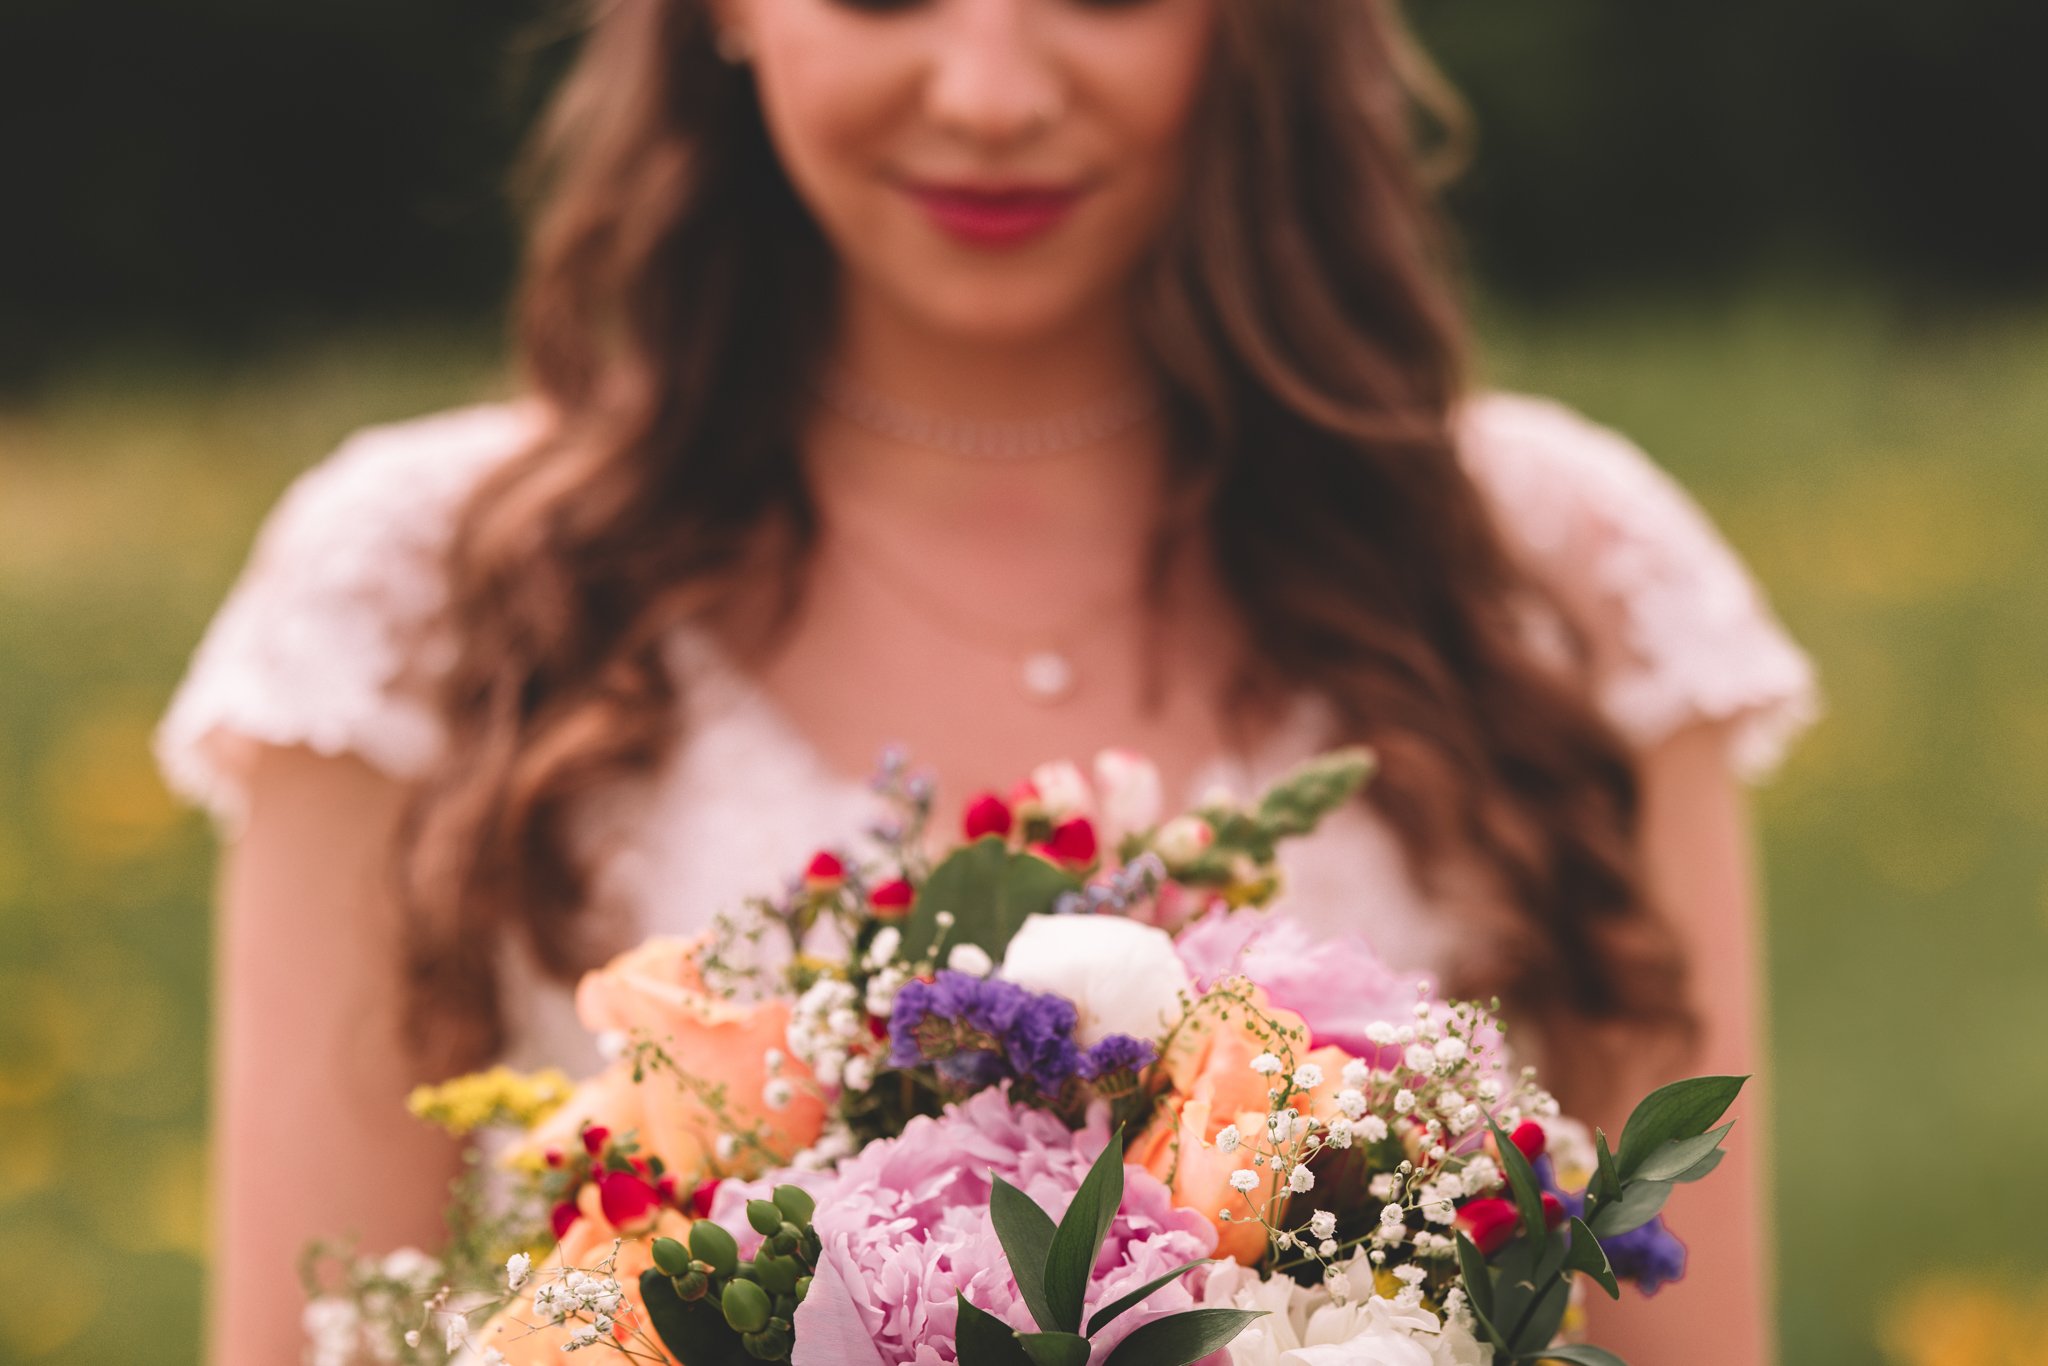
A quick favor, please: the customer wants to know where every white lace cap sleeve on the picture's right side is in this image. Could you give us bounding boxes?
[1460,393,1819,780]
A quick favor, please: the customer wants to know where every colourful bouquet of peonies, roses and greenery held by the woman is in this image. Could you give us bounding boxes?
[307,750,1743,1366]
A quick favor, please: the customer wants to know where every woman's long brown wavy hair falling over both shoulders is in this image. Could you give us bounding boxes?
[403,0,1690,1097]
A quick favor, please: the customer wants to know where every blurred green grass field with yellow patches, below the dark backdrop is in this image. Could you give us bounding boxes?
[0,293,2048,1366]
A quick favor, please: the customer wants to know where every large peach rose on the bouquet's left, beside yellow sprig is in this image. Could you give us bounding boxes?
[522,938,825,1190]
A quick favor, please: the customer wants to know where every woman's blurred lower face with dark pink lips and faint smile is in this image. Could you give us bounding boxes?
[721,0,1217,342]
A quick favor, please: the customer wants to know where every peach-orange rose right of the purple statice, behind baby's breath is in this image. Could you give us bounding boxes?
[1130,987,1350,1266]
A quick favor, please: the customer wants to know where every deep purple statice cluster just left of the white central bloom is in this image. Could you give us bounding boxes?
[889,969,1083,1094]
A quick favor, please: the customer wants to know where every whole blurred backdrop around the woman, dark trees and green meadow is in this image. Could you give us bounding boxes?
[0,0,2048,1366]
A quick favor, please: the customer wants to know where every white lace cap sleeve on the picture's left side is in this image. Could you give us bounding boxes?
[156,405,535,827]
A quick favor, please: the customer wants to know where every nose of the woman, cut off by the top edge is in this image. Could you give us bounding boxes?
[926,0,1067,147]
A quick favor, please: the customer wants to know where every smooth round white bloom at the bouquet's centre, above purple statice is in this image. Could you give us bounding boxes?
[997,915,1190,1047]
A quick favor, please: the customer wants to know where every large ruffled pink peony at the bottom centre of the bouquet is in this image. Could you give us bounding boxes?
[713,1090,1217,1366]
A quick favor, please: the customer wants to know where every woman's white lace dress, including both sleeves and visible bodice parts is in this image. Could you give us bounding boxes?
[158,393,1815,1069]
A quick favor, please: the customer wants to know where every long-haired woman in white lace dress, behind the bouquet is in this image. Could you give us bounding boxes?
[162,0,1808,1366]
